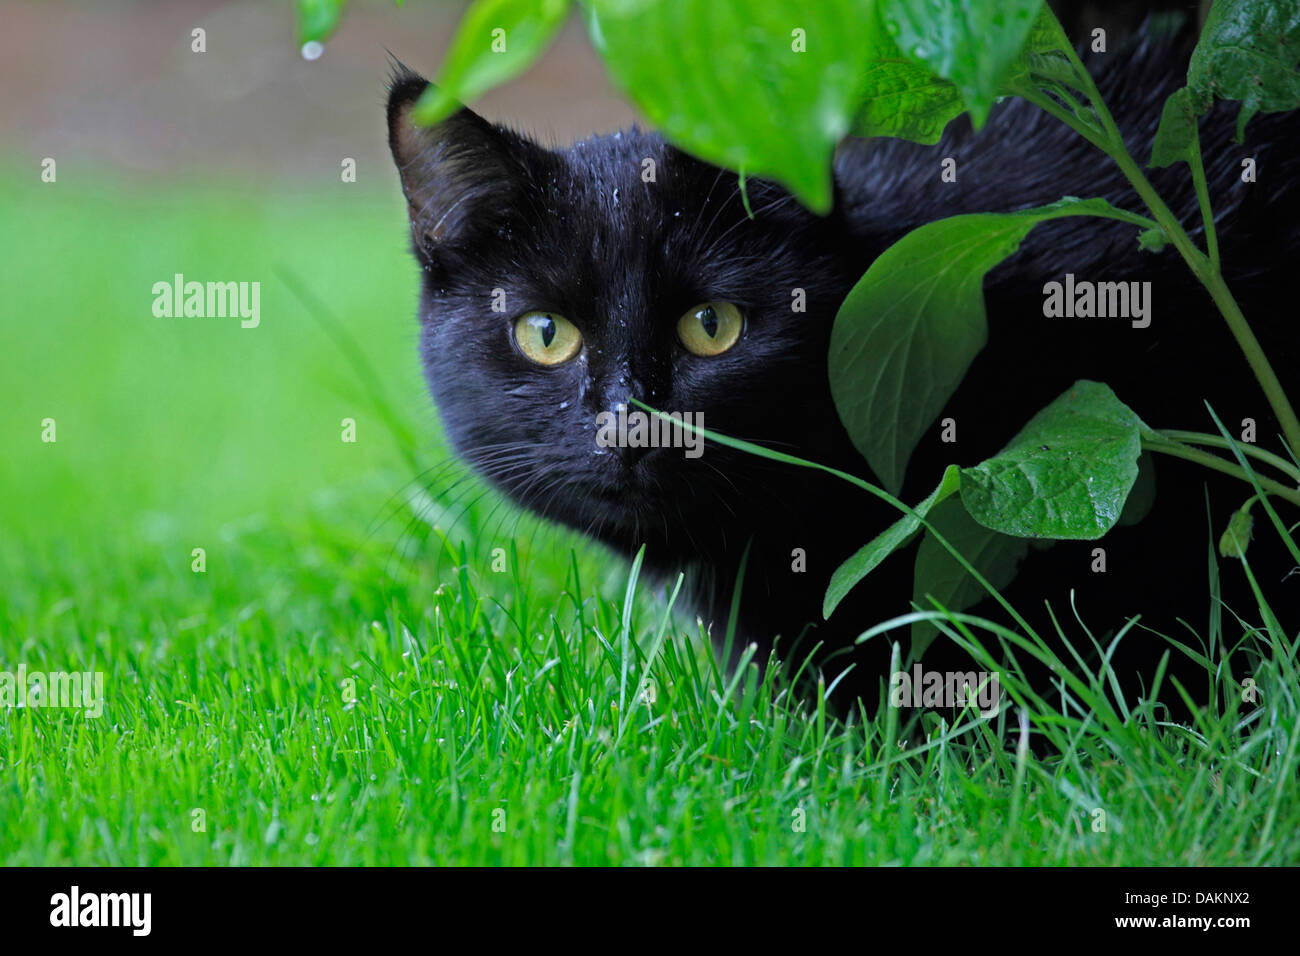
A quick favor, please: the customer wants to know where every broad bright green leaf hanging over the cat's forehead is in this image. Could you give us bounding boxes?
[588,0,874,212]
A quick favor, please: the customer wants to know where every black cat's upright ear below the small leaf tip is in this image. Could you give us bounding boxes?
[387,64,527,261]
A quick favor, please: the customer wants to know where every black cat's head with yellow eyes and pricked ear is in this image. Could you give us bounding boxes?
[389,75,861,554]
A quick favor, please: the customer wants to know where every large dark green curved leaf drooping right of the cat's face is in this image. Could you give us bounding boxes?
[829,198,1145,493]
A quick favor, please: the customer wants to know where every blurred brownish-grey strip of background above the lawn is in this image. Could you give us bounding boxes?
[0,0,634,178]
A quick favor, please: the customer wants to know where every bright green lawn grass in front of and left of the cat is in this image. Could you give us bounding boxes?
[0,170,1300,865]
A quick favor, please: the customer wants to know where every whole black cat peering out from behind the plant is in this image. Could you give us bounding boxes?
[389,22,1300,707]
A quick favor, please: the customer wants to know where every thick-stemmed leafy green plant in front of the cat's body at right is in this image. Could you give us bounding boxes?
[828,0,1300,629]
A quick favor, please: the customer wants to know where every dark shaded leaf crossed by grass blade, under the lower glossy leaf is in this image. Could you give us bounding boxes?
[911,501,1030,657]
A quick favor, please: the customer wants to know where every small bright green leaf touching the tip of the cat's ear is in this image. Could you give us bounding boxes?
[411,0,568,126]
